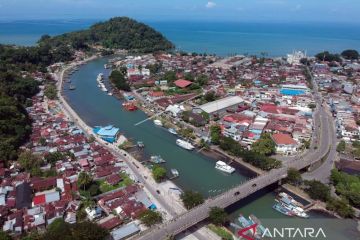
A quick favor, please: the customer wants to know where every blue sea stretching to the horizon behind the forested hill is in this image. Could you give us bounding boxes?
[0,19,360,57]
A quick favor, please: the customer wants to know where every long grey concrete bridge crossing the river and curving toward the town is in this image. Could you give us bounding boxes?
[134,73,334,240]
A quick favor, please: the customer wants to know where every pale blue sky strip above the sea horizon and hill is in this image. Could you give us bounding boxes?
[0,0,360,23]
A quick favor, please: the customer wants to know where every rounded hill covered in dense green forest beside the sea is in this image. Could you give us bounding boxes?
[40,17,174,53]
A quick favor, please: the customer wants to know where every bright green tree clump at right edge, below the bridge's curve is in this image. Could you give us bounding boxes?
[330,169,360,208]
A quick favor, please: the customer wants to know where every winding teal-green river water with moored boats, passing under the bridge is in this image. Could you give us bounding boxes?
[64,59,355,239]
